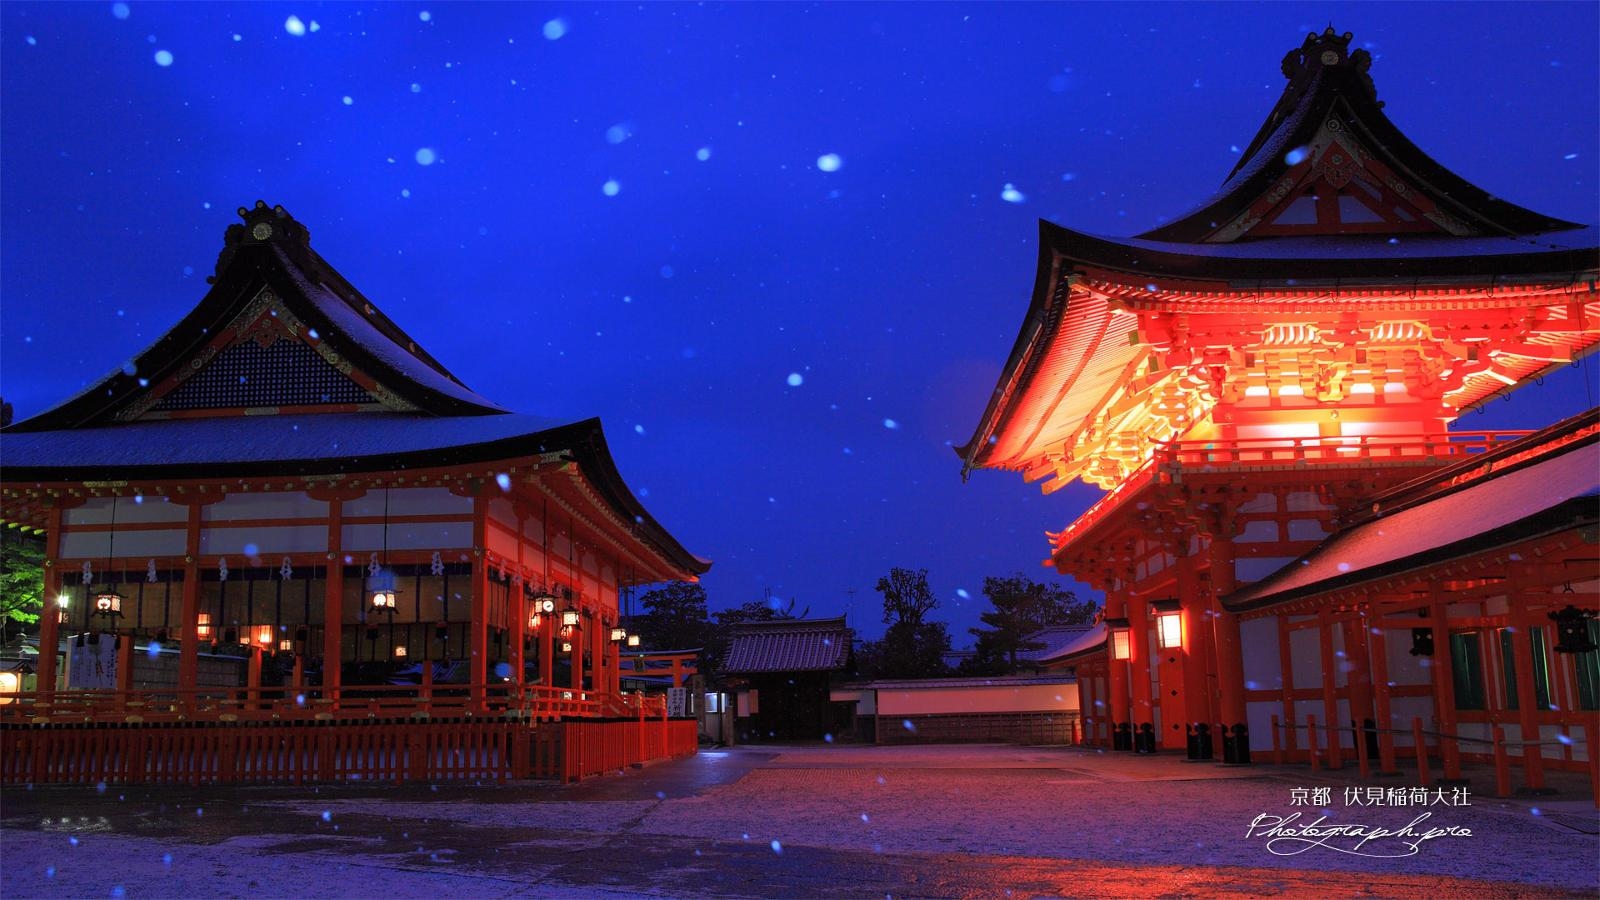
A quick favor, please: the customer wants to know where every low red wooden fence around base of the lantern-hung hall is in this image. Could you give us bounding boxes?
[0,684,698,785]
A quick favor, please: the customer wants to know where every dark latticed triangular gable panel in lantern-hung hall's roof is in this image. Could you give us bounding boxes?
[155,340,373,410]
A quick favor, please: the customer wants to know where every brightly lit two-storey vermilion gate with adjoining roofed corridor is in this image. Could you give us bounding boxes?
[958,29,1600,786]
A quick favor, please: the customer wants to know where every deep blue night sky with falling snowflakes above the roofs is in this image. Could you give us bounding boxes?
[0,2,1600,645]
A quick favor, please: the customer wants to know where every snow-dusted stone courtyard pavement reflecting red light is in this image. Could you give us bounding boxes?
[0,745,1600,898]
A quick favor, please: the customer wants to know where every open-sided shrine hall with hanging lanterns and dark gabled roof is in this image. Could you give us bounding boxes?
[0,202,710,781]
